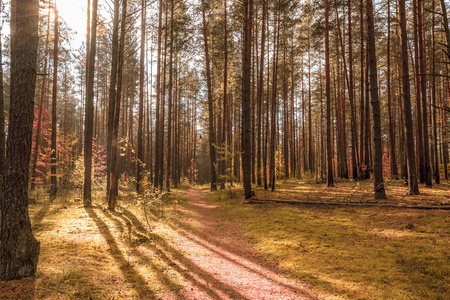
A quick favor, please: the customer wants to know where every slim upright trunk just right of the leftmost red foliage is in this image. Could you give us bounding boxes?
[50,7,59,196]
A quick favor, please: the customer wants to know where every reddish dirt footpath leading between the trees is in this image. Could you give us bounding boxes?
[158,189,317,299]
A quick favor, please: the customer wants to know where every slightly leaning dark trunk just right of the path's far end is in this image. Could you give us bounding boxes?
[202,0,217,191]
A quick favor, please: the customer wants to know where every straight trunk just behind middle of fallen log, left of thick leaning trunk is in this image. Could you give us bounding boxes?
[325,0,334,187]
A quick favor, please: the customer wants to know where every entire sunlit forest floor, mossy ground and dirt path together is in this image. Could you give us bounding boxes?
[0,181,450,299]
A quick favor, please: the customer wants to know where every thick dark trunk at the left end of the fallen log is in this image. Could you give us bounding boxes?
[242,0,253,199]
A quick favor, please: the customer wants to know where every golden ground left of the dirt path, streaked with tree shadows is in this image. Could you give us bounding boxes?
[0,190,192,299]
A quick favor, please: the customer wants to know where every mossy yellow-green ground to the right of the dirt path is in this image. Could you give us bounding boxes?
[203,181,450,299]
